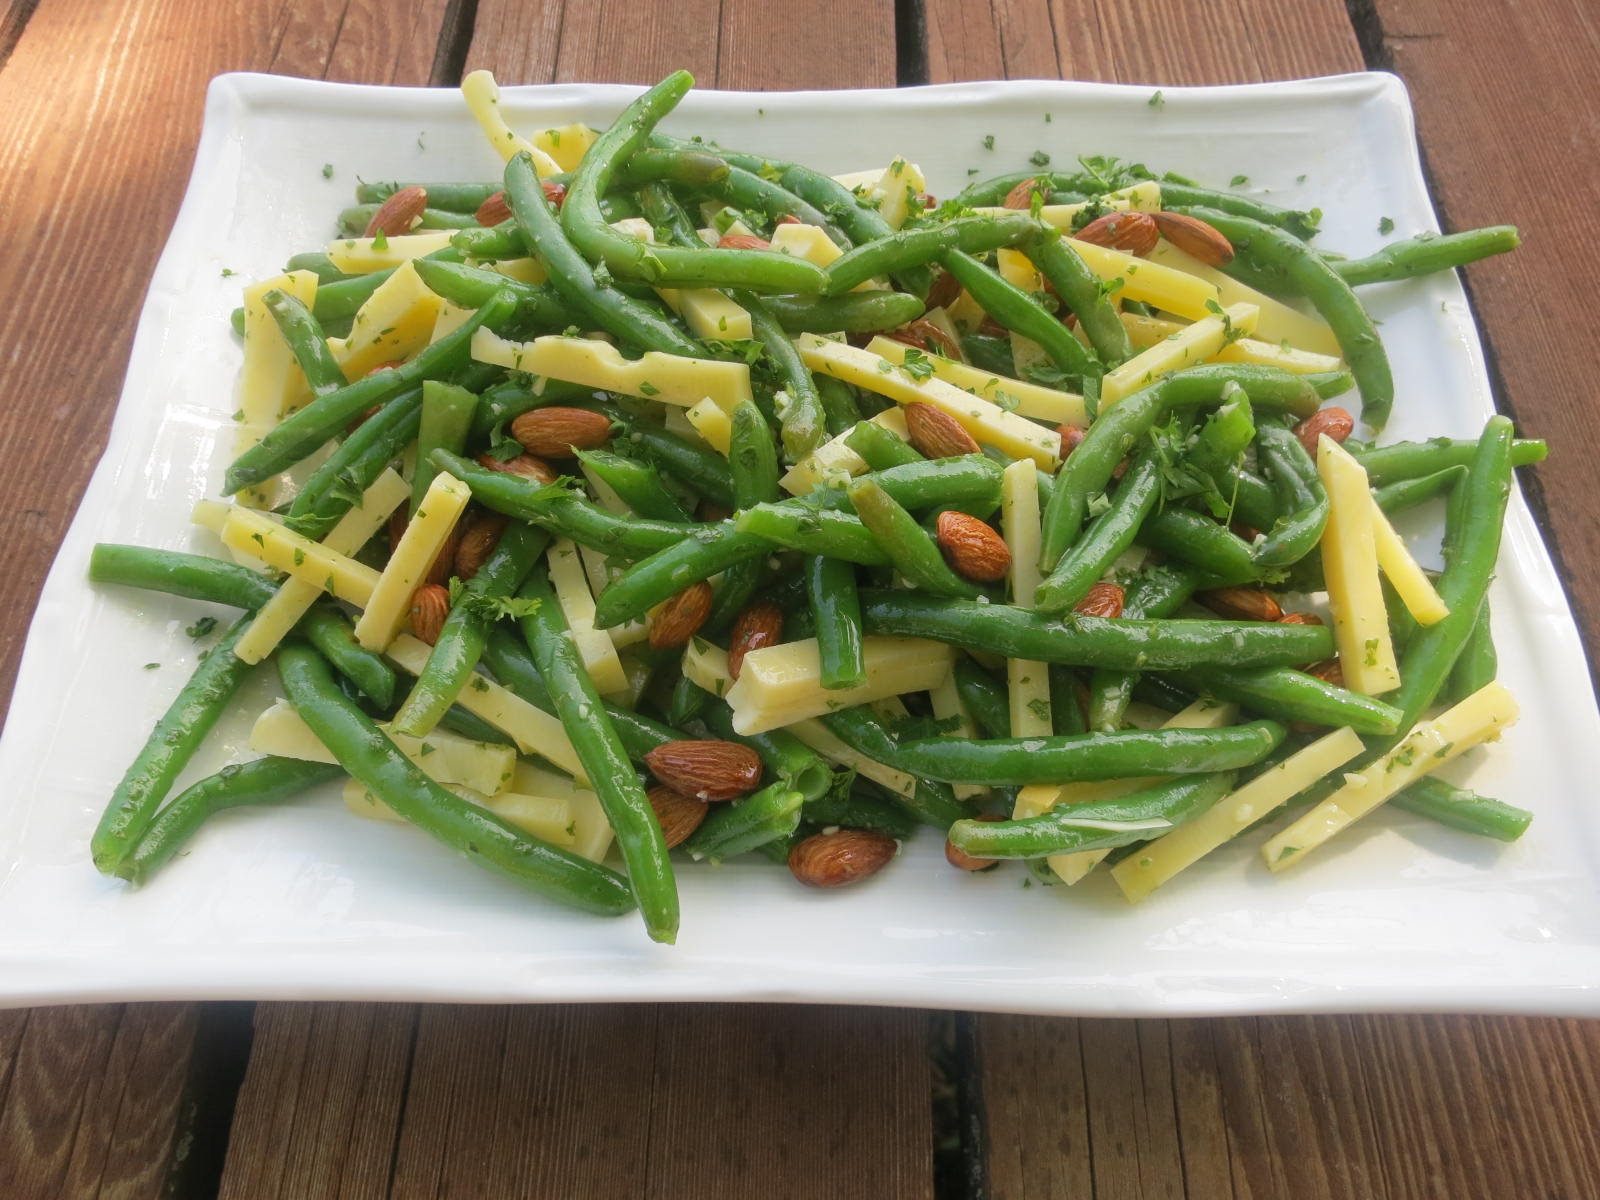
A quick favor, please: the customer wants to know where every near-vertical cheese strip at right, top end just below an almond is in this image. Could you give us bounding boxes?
[1317,434,1400,696]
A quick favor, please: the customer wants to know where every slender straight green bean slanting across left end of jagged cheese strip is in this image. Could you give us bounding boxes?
[222,291,515,494]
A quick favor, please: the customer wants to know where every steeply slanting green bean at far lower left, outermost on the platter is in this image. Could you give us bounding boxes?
[90,613,254,875]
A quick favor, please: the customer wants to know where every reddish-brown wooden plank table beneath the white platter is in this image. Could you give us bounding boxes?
[0,0,1600,1200]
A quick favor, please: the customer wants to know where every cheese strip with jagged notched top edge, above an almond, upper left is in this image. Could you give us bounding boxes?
[472,330,754,413]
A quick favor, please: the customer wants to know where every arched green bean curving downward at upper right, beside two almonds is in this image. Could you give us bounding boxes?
[1174,206,1394,429]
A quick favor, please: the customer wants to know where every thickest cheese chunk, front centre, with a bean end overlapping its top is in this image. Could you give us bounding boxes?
[726,637,952,734]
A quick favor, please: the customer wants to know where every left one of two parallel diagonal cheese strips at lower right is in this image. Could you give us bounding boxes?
[1110,730,1363,904]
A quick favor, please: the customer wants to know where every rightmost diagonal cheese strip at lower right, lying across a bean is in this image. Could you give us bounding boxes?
[1261,683,1517,870]
